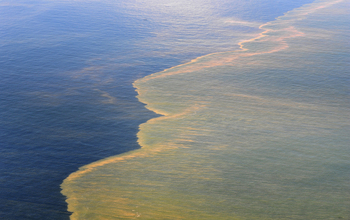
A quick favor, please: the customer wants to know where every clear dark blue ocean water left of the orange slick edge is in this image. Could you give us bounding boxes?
[4,0,343,219]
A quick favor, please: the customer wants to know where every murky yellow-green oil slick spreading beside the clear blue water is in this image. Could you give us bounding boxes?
[61,0,350,219]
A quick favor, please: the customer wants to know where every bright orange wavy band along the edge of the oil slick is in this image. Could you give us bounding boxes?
[61,0,344,219]
